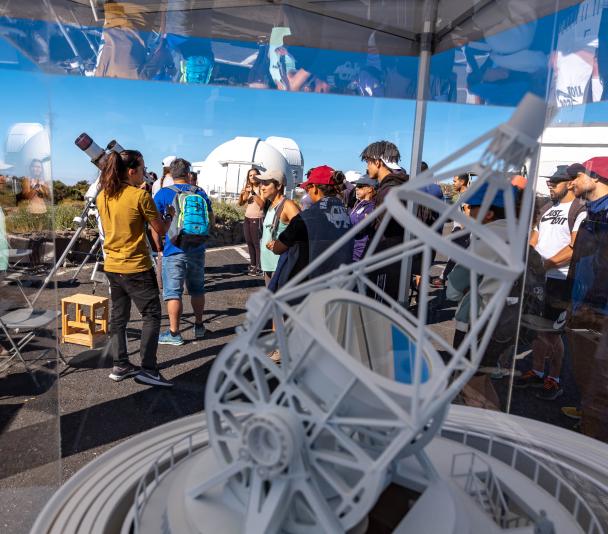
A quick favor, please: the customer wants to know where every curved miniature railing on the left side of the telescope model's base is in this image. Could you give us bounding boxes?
[133,428,209,534]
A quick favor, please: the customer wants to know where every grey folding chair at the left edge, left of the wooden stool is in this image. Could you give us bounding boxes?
[0,308,67,387]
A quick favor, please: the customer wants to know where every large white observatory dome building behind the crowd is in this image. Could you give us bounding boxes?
[192,137,304,195]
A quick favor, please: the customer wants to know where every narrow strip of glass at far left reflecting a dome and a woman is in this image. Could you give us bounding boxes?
[0,71,61,532]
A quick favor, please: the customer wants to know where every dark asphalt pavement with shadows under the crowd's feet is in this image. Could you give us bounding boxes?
[0,246,577,533]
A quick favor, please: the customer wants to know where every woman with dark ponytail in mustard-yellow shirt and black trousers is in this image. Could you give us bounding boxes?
[97,150,173,387]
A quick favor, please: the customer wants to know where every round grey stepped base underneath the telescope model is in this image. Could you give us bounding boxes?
[32,405,608,534]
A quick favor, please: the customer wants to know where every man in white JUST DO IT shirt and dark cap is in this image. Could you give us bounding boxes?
[515,165,587,400]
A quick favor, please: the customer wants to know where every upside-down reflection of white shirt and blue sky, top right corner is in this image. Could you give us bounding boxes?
[429,0,608,109]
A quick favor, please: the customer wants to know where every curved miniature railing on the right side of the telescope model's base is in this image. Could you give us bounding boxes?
[441,424,607,534]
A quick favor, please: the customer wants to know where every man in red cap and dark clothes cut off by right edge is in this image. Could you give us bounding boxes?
[562,157,608,441]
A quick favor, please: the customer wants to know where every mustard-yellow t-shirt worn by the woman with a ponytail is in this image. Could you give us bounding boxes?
[97,185,158,274]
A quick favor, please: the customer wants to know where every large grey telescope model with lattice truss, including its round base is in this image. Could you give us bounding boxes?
[35,97,608,534]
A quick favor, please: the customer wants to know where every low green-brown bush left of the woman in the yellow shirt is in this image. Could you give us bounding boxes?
[6,203,89,234]
